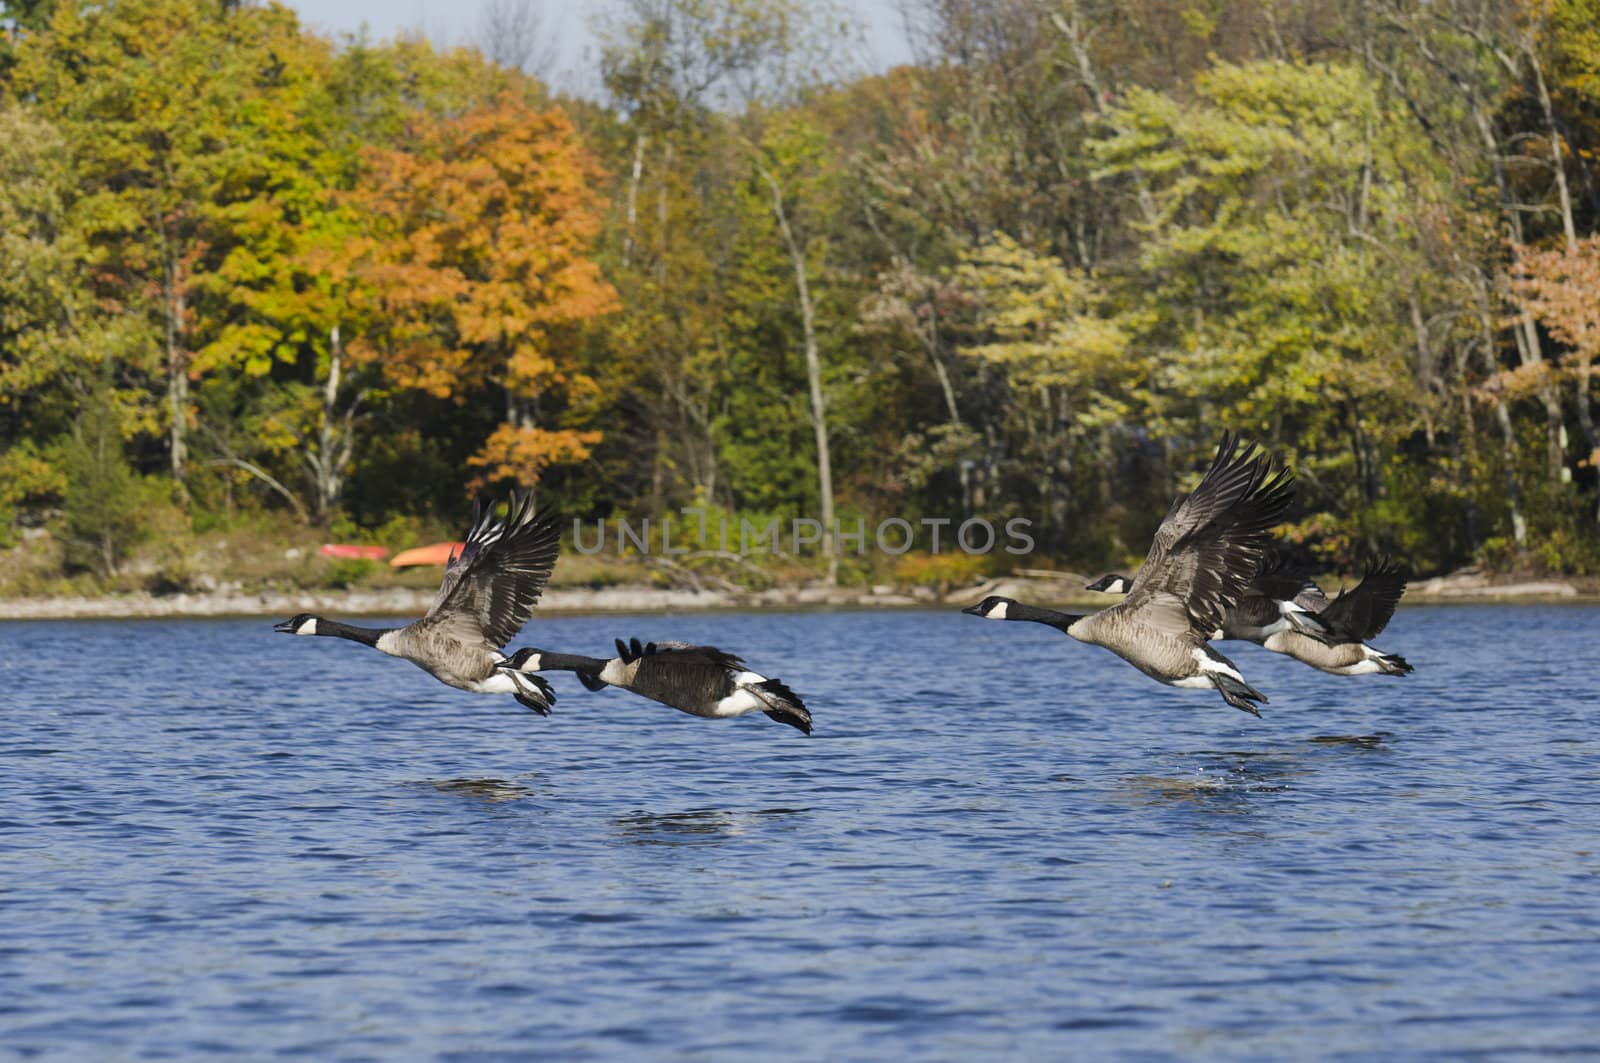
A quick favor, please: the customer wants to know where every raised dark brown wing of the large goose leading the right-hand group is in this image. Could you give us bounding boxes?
[1106,432,1293,642]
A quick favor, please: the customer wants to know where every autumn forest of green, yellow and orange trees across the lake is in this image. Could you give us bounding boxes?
[0,0,1600,598]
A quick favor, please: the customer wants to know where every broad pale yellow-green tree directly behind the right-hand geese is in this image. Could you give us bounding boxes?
[1094,62,1459,557]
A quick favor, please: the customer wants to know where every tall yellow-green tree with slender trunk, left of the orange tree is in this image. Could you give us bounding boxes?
[14,0,315,475]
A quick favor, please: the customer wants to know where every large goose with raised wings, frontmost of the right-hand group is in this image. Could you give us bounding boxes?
[962,432,1293,716]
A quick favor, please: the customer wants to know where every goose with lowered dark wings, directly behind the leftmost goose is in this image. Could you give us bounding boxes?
[501,639,811,735]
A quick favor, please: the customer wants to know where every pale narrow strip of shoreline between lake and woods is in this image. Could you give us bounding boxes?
[0,570,1600,621]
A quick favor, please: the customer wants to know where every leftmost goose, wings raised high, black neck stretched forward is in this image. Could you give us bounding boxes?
[274,490,562,716]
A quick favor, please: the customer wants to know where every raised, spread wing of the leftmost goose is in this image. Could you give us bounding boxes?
[418,490,562,647]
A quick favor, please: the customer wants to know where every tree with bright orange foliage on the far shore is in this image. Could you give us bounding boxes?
[349,94,618,487]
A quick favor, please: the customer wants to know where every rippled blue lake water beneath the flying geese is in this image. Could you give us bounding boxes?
[0,607,1600,1060]
